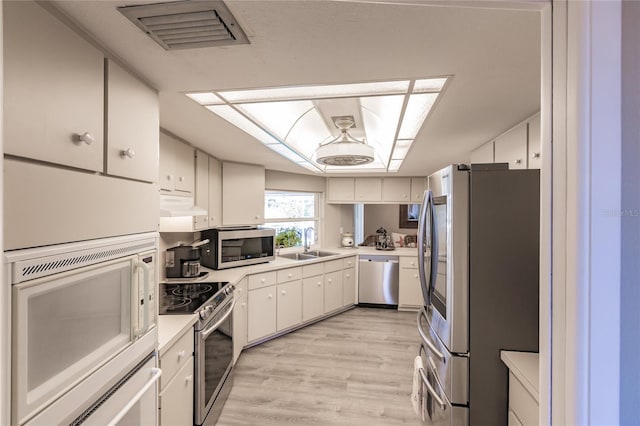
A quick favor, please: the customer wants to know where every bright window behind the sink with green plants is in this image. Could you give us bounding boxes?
[264,191,320,247]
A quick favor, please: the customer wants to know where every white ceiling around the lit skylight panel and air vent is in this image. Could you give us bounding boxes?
[55,0,540,176]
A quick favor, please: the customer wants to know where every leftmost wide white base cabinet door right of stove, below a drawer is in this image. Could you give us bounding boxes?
[247,286,276,342]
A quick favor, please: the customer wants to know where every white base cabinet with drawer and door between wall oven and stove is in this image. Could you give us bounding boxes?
[160,328,194,426]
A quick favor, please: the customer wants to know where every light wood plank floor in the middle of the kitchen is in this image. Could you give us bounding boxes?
[217,308,420,426]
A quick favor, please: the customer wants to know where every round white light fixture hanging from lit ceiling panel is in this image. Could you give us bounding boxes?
[314,116,375,166]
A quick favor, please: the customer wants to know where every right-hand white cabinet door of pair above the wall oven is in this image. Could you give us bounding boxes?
[106,60,160,182]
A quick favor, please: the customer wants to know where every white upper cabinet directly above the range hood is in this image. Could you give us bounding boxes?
[158,132,195,195]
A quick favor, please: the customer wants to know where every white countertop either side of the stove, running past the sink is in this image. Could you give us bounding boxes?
[158,247,418,356]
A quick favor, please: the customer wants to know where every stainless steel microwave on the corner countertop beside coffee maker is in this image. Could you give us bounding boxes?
[200,228,276,269]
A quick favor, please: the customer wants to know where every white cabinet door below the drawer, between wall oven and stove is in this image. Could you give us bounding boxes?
[160,356,193,426]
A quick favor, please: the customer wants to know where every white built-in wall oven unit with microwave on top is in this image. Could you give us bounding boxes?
[5,233,160,425]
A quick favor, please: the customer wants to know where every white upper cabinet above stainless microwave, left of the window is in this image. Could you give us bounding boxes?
[222,163,265,226]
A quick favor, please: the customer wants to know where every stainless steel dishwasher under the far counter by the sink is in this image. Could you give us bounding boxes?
[358,254,399,306]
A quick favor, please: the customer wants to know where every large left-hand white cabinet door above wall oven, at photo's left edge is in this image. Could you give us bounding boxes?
[2,1,104,172]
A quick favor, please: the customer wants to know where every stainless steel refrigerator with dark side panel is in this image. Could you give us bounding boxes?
[418,164,540,426]
